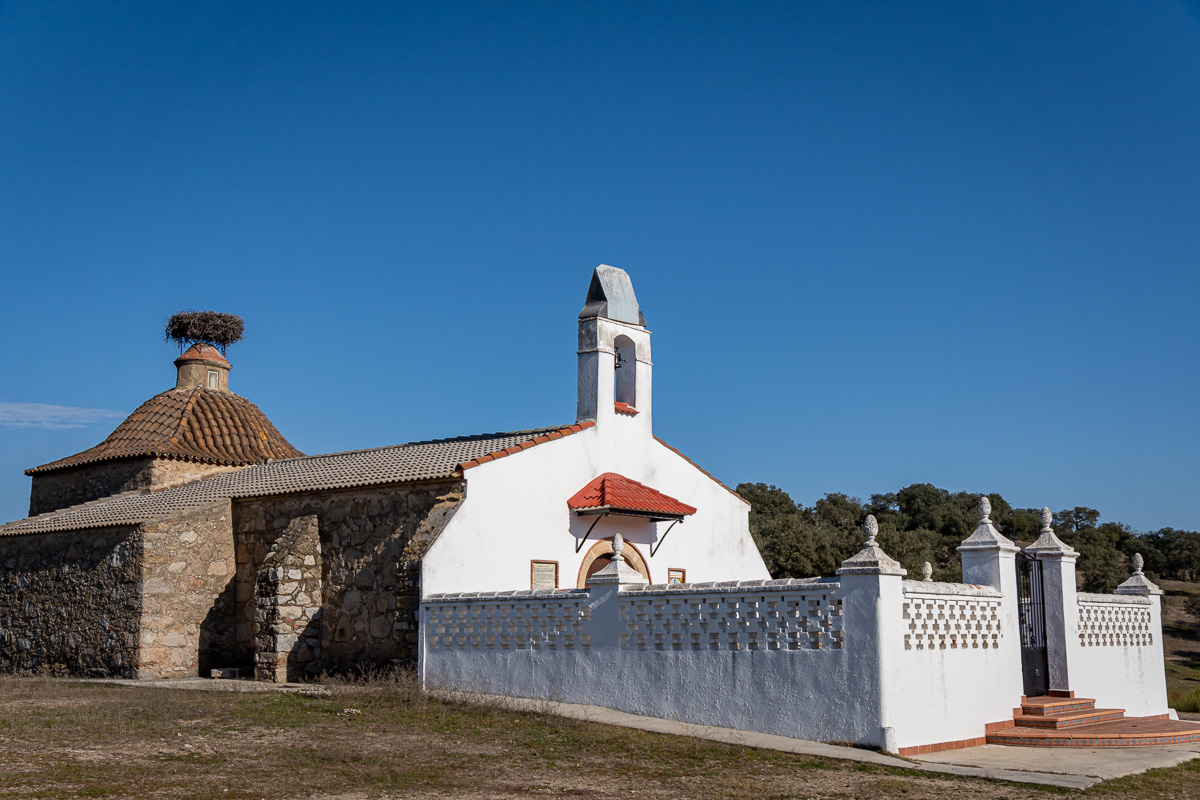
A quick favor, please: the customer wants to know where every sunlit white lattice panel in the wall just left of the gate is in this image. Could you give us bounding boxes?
[904,591,1002,650]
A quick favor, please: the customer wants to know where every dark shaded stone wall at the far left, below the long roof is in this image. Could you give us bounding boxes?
[0,527,142,678]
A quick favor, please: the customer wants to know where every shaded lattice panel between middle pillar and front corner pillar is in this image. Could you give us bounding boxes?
[620,589,844,650]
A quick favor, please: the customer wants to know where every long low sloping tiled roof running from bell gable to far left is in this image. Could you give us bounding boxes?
[0,422,594,536]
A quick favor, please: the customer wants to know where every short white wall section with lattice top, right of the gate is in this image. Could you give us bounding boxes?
[1067,593,1168,716]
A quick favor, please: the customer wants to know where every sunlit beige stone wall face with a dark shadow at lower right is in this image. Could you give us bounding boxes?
[138,500,235,678]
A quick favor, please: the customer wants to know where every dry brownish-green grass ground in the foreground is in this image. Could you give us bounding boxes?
[0,674,1200,800]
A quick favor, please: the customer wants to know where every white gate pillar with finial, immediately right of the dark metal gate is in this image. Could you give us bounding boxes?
[1025,507,1082,692]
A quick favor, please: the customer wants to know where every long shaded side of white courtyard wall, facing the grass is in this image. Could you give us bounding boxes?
[421,581,902,745]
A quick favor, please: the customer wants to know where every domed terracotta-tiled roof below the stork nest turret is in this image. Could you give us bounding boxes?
[25,386,304,475]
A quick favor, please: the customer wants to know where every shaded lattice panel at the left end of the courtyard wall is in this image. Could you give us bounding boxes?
[425,593,592,650]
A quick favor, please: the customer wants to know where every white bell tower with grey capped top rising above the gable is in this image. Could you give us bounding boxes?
[576,264,653,433]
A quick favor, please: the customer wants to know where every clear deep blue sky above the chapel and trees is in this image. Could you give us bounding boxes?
[0,2,1200,530]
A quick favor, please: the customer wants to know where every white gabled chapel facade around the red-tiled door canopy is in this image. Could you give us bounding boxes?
[421,415,770,596]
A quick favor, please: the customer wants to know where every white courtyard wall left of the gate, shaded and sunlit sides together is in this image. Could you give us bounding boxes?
[421,575,1041,750]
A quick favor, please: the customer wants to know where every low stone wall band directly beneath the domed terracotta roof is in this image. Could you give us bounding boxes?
[29,458,241,517]
